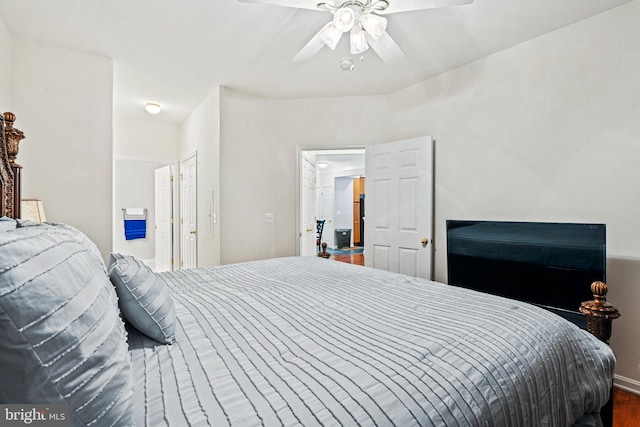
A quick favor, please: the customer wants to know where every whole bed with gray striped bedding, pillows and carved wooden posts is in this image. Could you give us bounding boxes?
[0,113,615,427]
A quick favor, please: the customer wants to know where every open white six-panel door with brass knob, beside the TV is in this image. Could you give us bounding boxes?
[364,136,433,279]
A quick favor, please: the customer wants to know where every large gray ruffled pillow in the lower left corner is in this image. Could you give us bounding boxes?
[0,225,133,426]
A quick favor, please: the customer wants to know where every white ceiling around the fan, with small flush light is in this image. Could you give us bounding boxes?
[0,0,631,123]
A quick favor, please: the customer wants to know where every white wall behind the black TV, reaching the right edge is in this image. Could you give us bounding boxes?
[391,1,640,391]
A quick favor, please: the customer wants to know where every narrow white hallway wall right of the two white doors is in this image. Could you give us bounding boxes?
[179,88,221,267]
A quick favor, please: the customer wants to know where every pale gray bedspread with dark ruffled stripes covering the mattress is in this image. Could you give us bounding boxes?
[129,257,615,427]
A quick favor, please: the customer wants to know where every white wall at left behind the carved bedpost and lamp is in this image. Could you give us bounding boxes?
[11,37,113,257]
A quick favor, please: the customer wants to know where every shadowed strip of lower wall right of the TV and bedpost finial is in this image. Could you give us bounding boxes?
[607,257,640,393]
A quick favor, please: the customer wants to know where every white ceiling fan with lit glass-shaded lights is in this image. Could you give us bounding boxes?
[240,0,474,64]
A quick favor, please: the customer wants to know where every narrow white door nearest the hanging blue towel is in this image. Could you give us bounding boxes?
[154,165,173,272]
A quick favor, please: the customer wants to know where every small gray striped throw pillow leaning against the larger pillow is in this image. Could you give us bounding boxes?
[109,253,176,344]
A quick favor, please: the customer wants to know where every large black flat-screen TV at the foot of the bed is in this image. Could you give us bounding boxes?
[447,220,606,312]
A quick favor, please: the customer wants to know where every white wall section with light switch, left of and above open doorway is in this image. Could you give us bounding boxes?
[220,88,391,264]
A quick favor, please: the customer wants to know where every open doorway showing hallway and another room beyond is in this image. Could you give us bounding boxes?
[297,147,365,256]
